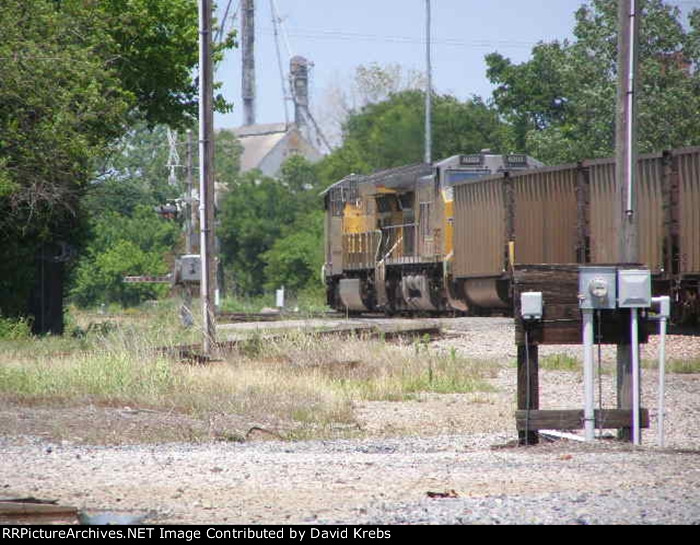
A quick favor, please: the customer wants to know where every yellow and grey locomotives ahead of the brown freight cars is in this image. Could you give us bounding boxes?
[323,153,541,314]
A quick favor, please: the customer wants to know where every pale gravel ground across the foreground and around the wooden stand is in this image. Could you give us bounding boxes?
[0,318,700,525]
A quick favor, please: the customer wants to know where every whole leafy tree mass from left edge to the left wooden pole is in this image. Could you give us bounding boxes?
[0,0,231,332]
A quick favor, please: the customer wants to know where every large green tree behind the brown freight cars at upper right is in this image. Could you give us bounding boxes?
[486,0,700,163]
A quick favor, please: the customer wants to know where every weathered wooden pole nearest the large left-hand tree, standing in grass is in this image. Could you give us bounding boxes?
[199,0,216,356]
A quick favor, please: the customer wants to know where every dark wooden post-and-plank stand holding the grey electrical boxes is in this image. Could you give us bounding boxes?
[511,264,652,445]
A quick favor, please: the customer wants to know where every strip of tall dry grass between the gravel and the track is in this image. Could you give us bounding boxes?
[0,327,495,436]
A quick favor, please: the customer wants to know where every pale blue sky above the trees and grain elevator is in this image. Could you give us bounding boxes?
[215,0,690,129]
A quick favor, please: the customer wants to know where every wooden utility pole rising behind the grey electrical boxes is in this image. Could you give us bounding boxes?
[615,0,640,441]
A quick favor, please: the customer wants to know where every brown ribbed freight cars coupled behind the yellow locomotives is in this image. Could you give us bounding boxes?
[452,144,700,323]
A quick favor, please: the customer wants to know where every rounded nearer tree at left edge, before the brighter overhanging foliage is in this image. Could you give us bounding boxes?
[0,0,130,324]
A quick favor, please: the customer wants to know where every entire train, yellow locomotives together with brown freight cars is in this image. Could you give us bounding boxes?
[323,148,700,323]
